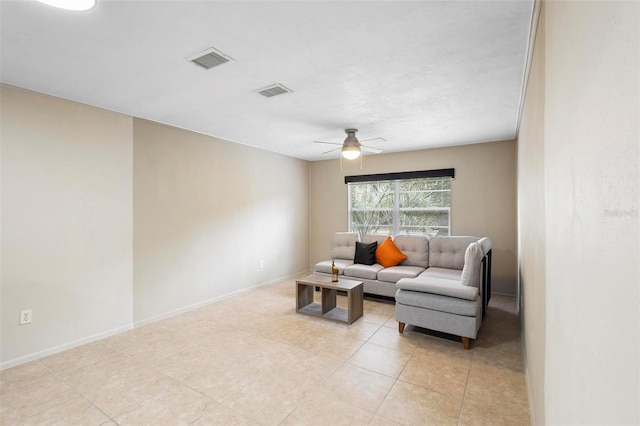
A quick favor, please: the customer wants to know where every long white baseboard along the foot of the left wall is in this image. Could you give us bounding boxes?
[0,270,309,371]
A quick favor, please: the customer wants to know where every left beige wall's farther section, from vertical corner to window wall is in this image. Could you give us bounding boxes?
[133,119,309,322]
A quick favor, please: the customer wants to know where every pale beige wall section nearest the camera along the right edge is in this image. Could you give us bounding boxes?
[544,1,640,424]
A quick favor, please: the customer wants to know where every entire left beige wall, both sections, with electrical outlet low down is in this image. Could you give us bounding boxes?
[0,85,309,369]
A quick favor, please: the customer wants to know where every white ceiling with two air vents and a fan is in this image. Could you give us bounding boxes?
[0,0,533,160]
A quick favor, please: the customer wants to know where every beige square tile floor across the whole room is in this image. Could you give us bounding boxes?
[0,280,529,425]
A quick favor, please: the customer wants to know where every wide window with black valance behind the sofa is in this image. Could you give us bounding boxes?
[345,169,453,237]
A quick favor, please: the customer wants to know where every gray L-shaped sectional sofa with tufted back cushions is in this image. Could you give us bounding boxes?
[314,232,491,349]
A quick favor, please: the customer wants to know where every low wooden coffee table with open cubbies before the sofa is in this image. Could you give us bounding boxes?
[296,275,364,324]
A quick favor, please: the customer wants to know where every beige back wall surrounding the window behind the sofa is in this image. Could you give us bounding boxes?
[309,141,517,295]
